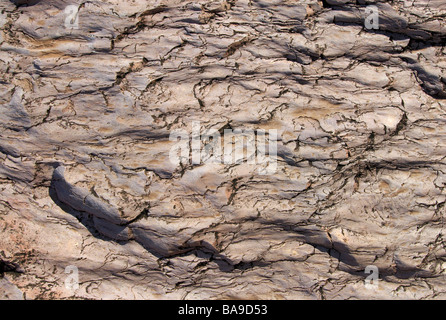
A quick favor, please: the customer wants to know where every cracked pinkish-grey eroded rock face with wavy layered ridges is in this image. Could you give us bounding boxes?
[0,0,446,299]
